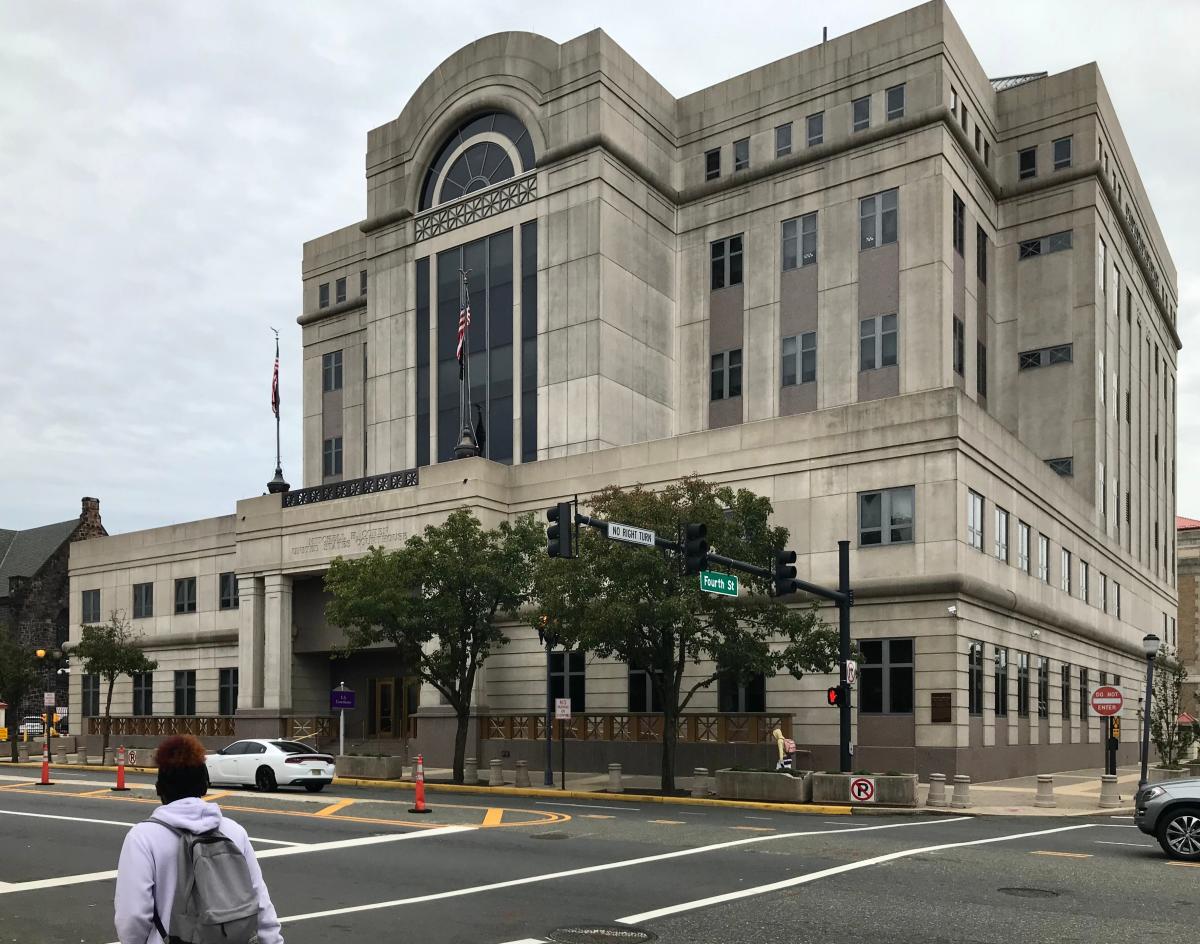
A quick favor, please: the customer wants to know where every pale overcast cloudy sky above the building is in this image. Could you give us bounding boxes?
[0,0,1200,533]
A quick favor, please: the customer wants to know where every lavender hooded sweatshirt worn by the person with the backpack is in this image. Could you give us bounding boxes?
[115,796,283,944]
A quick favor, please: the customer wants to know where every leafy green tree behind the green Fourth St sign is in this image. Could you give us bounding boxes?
[533,477,838,790]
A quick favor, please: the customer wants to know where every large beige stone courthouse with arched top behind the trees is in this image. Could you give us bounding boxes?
[71,0,1180,777]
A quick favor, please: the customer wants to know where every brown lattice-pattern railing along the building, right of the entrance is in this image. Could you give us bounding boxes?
[480,712,792,744]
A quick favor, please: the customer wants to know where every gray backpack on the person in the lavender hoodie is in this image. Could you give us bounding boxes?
[146,817,258,944]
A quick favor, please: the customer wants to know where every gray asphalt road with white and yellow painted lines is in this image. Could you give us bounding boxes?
[0,769,1200,944]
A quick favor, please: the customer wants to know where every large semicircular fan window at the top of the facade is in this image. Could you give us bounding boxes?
[419,112,533,210]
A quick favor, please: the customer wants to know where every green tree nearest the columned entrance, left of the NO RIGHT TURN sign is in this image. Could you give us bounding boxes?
[325,509,542,783]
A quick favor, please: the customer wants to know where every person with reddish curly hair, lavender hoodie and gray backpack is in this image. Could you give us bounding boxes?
[114,735,283,944]
